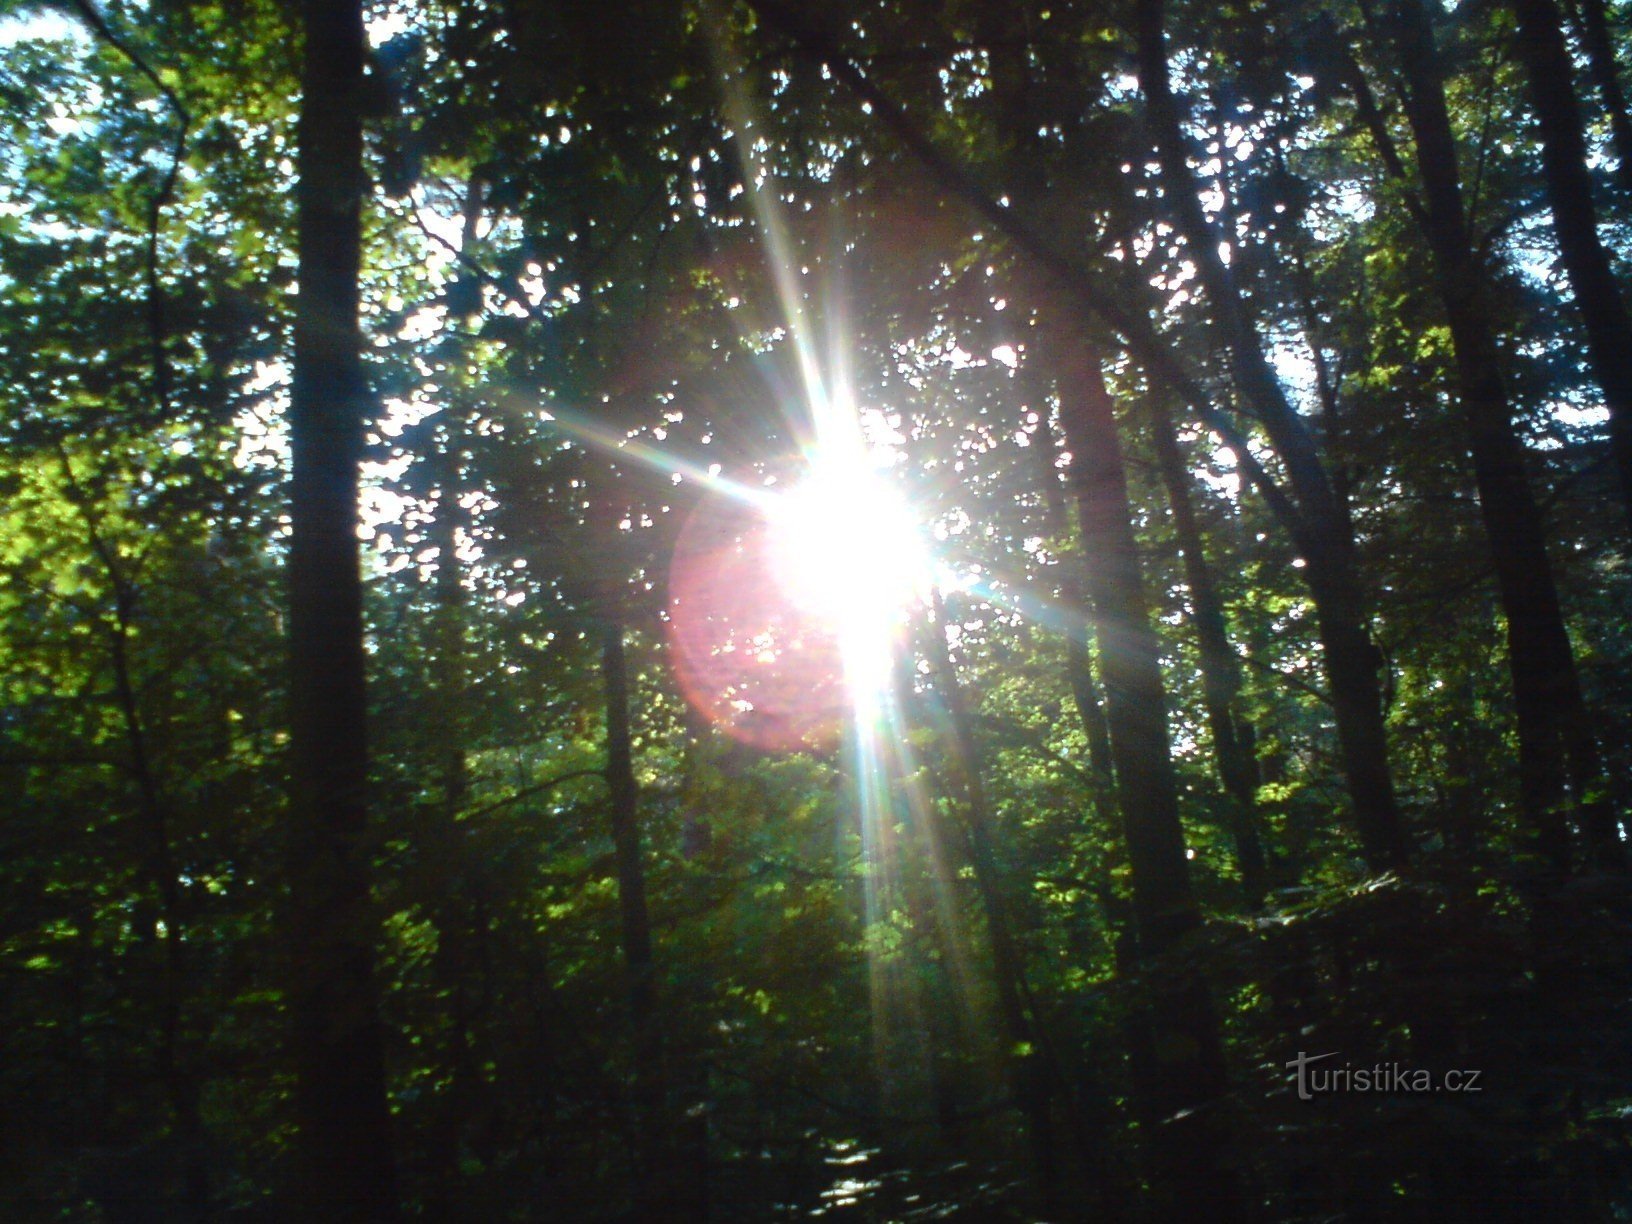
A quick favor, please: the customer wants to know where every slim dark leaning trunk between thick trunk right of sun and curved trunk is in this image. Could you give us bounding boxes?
[1151,401,1268,909]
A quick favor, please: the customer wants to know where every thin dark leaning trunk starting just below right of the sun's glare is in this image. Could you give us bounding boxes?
[930,591,1059,1200]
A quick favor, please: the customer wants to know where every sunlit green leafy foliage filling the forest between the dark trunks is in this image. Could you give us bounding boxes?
[0,0,1632,1221]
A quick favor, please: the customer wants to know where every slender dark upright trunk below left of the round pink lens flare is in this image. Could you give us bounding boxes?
[601,622,672,1219]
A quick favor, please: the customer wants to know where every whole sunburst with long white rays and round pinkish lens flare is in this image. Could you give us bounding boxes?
[496,24,974,1109]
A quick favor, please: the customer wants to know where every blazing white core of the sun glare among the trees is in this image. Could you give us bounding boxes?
[769,459,932,697]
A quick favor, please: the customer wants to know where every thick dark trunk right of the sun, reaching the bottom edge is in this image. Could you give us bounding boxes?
[1044,328,1242,1221]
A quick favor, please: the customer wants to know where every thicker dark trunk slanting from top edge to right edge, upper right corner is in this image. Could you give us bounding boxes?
[1513,0,1632,538]
